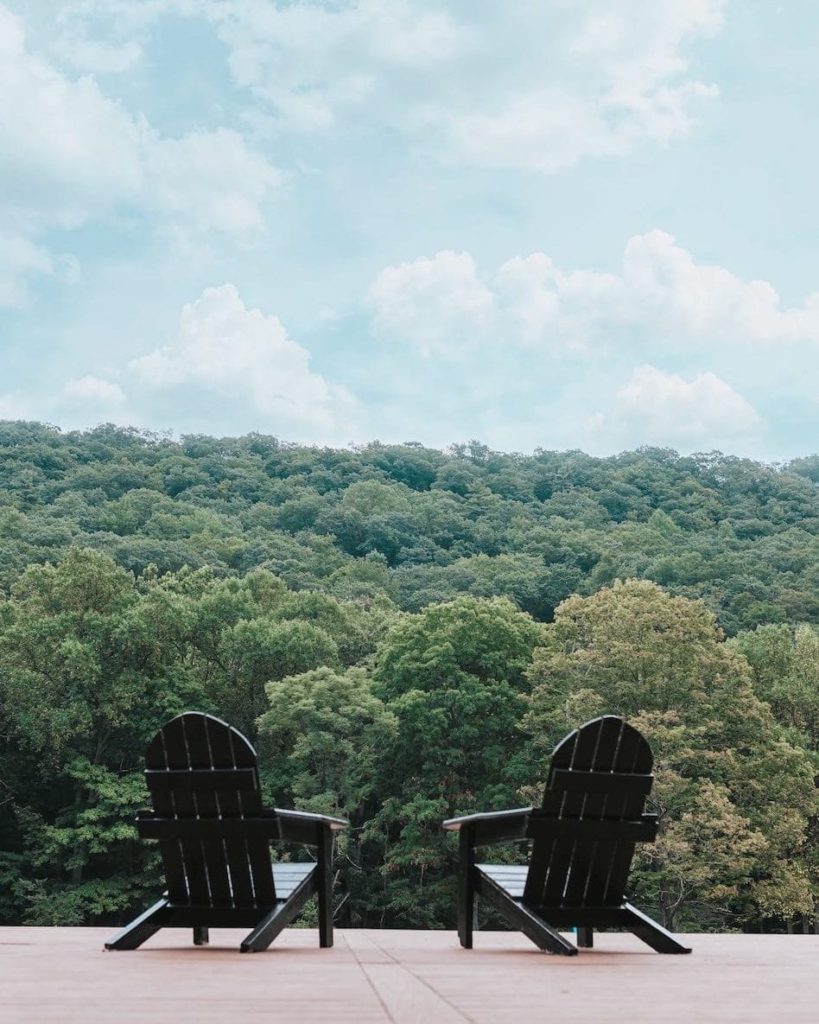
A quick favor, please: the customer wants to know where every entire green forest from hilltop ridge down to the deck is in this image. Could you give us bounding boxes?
[0,421,819,931]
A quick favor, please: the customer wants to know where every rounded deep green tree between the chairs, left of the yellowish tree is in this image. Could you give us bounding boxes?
[368,597,542,927]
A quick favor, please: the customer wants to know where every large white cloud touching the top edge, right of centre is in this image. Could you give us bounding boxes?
[439,0,724,172]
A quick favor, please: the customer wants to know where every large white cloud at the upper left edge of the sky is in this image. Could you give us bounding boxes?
[0,6,282,304]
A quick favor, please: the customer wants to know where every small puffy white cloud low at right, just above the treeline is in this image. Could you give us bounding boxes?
[592,366,765,451]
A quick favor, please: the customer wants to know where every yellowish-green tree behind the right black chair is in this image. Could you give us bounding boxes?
[526,581,816,927]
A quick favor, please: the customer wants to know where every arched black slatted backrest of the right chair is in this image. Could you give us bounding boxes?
[523,715,655,907]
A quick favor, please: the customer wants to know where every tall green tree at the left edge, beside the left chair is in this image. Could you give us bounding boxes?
[0,550,203,924]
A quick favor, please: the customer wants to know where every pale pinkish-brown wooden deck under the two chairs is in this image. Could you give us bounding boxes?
[0,928,819,1024]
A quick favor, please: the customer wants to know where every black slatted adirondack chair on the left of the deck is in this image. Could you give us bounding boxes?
[105,712,347,952]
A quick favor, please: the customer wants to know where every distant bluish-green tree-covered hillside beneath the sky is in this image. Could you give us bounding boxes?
[0,422,819,635]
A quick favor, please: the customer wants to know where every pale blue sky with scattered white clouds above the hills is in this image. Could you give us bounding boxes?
[0,0,819,461]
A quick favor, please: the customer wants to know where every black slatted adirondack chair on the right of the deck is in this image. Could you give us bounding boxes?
[443,715,691,955]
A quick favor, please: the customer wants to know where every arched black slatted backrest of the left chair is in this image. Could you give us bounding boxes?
[145,712,275,906]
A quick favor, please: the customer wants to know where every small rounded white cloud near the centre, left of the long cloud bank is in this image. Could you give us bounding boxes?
[368,251,494,354]
